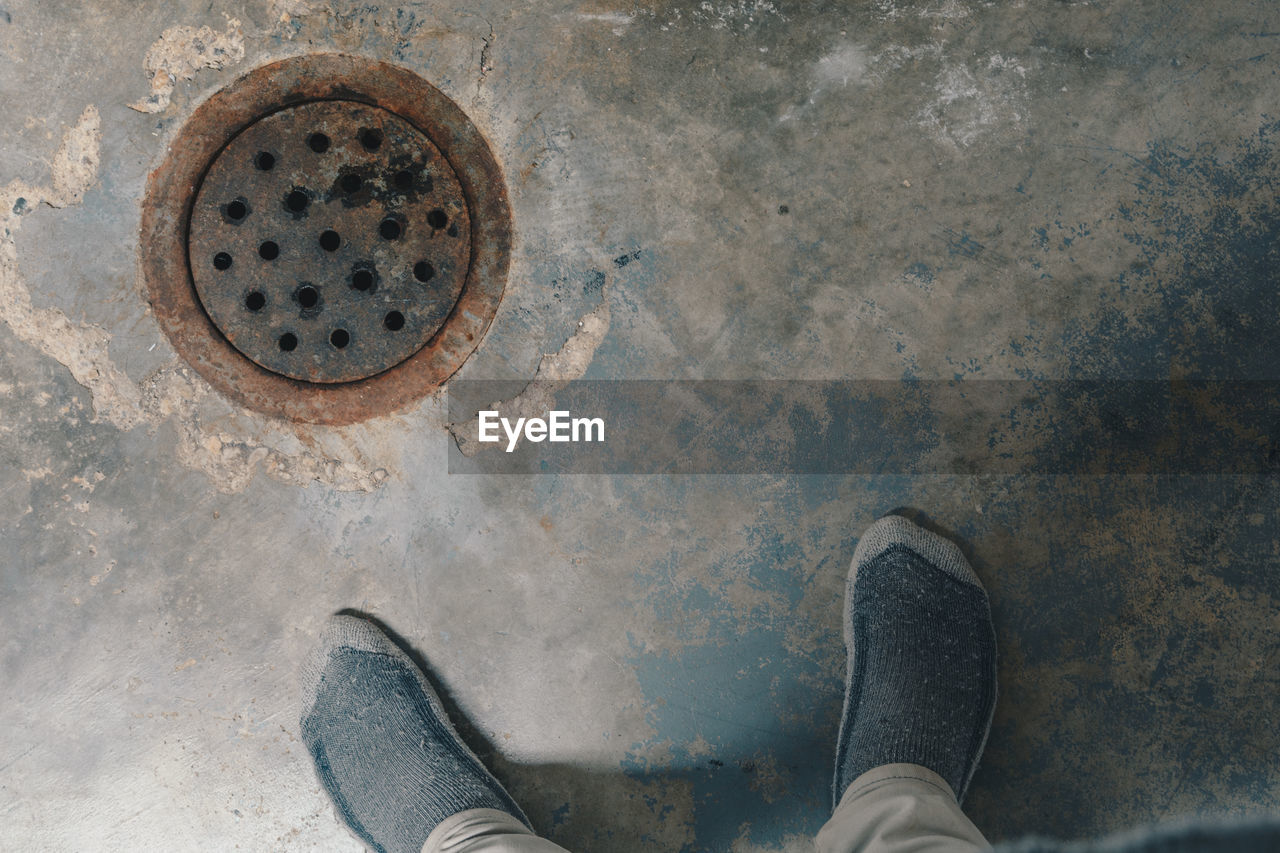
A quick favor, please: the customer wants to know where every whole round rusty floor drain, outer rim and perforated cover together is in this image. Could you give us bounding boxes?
[142,55,511,424]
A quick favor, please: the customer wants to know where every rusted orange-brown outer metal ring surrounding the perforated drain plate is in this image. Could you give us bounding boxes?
[140,54,512,425]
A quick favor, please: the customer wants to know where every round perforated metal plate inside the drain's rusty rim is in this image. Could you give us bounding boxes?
[188,101,471,382]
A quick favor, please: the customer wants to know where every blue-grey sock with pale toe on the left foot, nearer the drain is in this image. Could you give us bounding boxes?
[301,616,529,853]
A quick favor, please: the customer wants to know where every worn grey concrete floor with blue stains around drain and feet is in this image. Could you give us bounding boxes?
[0,0,1280,853]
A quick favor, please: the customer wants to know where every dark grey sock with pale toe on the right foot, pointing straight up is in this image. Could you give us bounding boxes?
[833,516,996,803]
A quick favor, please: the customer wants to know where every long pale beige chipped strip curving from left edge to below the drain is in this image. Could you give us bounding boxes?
[0,105,389,492]
